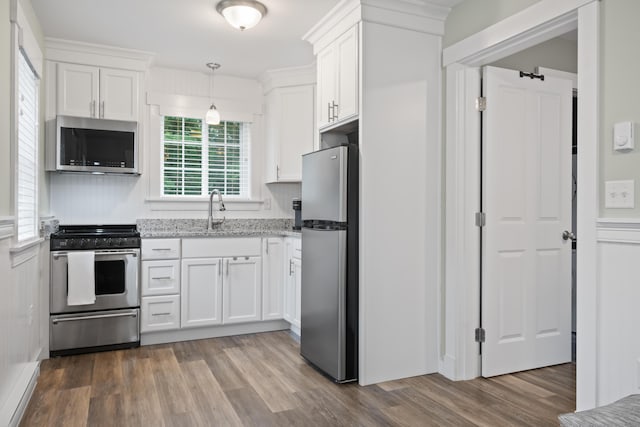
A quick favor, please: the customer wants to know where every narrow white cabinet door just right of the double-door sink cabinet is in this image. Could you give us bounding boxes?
[262,237,285,320]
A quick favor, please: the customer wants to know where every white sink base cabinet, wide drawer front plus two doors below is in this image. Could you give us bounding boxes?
[181,238,262,328]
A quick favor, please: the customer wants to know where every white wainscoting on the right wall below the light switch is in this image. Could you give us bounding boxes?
[596,219,640,405]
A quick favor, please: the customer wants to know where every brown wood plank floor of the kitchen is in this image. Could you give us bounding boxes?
[21,332,575,427]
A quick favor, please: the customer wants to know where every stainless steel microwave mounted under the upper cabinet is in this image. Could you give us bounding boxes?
[46,116,139,174]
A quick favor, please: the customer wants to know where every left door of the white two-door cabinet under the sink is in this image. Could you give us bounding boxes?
[180,258,223,328]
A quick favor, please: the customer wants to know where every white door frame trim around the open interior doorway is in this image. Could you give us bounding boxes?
[438,0,600,410]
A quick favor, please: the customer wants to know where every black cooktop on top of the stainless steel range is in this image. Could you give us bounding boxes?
[51,224,140,250]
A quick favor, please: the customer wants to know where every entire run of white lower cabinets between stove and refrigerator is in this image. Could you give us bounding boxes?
[141,237,292,343]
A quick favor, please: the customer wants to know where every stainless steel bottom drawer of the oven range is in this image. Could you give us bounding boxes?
[49,308,140,353]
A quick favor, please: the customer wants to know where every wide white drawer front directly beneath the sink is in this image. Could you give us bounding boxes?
[182,237,261,258]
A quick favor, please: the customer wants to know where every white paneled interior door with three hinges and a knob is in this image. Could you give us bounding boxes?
[481,67,572,377]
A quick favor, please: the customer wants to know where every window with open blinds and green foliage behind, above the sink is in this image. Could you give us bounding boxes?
[162,116,251,198]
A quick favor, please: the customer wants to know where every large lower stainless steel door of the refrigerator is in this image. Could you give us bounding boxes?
[300,228,349,381]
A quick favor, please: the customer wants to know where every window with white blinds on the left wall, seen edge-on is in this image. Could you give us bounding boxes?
[16,51,39,242]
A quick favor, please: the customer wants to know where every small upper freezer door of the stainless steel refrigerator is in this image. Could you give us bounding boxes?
[302,147,349,222]
